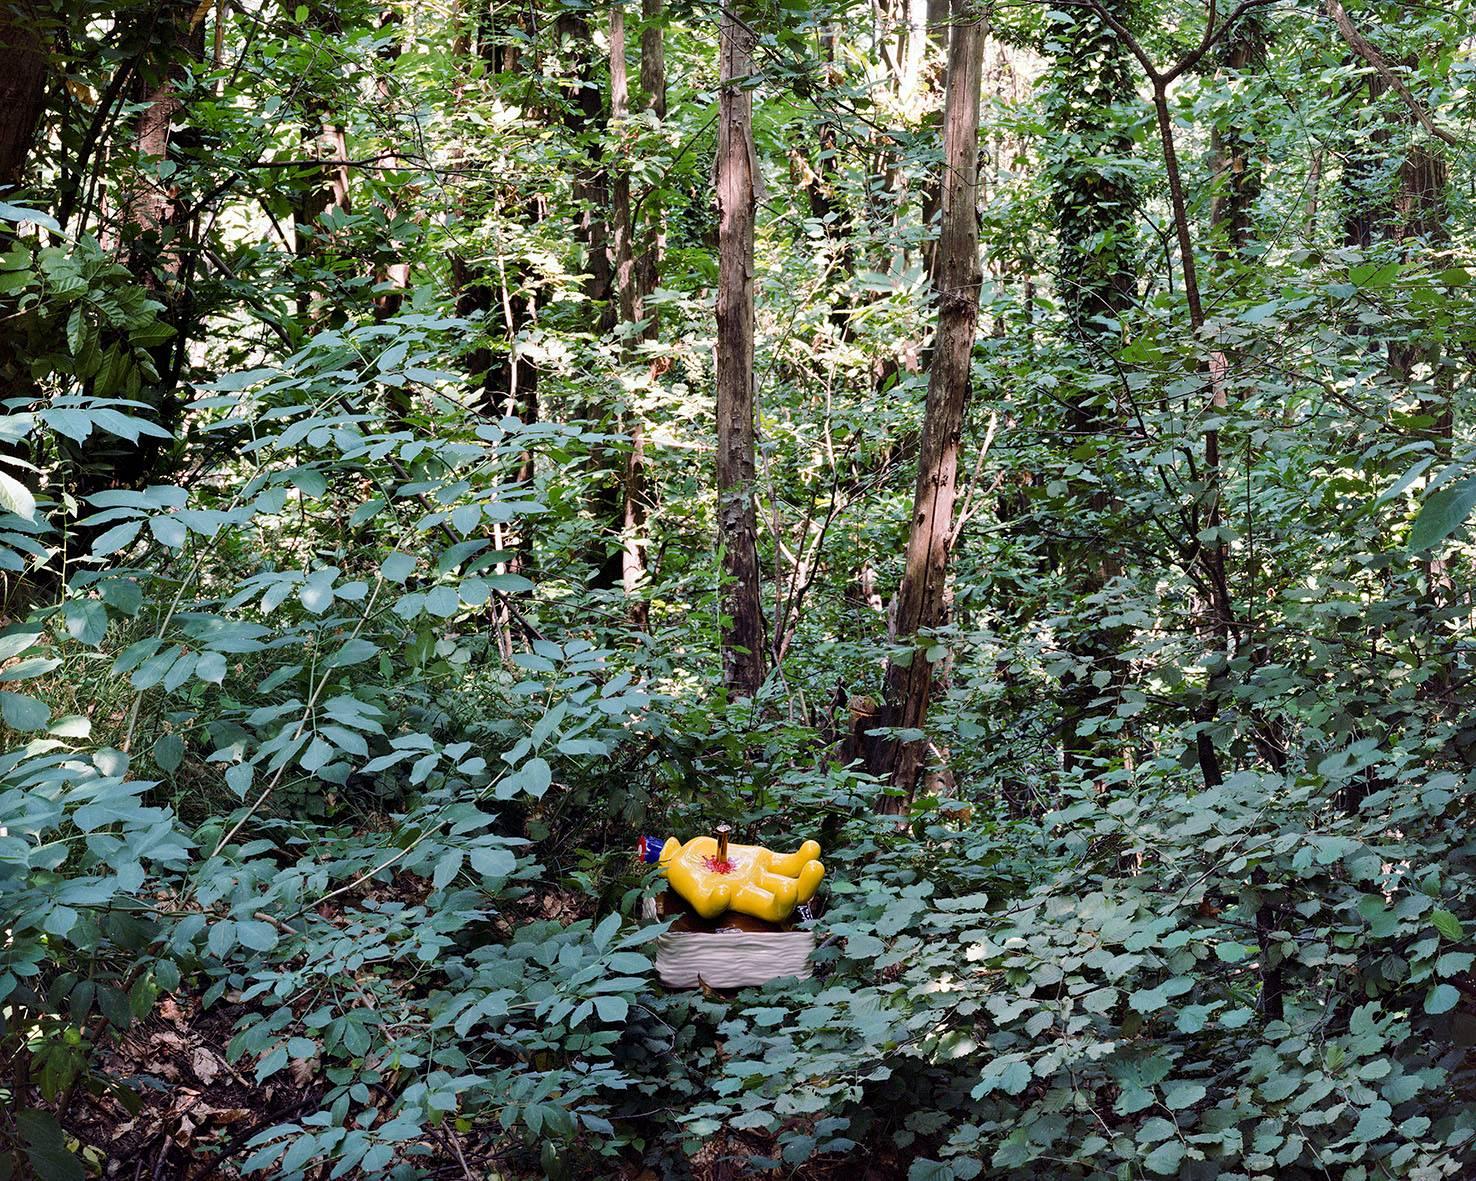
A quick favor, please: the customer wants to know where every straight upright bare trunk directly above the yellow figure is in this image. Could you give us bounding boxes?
[717,7,765,697]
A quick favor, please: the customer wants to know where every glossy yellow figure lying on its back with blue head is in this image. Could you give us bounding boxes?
[641,824,825,923]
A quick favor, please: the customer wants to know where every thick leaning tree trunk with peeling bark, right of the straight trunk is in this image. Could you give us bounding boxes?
[872,0,984,800]
